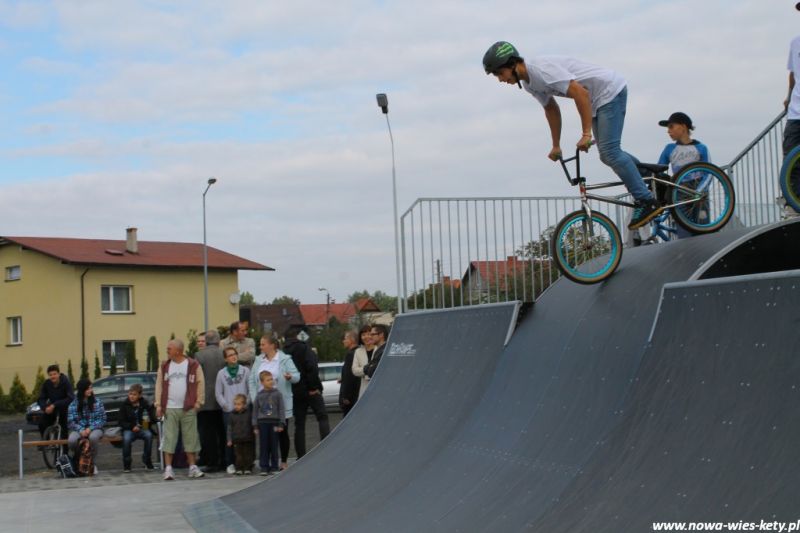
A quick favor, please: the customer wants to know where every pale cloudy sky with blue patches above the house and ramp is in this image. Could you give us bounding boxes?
[0,0,800,303]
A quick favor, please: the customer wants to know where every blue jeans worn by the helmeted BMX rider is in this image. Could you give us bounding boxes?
[592,87,653,201]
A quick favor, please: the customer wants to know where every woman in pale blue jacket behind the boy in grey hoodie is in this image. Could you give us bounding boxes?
[248,335,300,470]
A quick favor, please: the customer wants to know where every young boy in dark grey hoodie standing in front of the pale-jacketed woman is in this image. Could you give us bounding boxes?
[253,370,286,476]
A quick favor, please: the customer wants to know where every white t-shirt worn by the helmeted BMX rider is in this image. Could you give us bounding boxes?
[520,56,625,117]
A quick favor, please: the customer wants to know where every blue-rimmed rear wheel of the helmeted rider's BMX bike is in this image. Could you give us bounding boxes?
[671,163,736,234]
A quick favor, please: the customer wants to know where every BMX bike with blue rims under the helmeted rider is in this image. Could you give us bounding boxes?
[550,150,736,284]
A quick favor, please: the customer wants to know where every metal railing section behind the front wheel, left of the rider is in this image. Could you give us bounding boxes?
[400,197,625,311]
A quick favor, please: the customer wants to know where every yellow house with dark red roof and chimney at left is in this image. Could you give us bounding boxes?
[0,228,273,390]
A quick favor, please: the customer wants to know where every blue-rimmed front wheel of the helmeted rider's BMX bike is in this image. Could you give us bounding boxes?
[551,210,622,284]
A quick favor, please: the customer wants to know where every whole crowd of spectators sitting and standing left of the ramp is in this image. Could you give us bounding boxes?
[38,322,388,481]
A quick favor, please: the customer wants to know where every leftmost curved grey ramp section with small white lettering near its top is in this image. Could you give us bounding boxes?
[184,302,518,532]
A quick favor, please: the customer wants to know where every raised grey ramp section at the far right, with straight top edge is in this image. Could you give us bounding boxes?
[532,270,800,533]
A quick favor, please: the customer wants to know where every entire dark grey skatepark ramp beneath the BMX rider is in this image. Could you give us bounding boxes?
[185,218,800,532]
